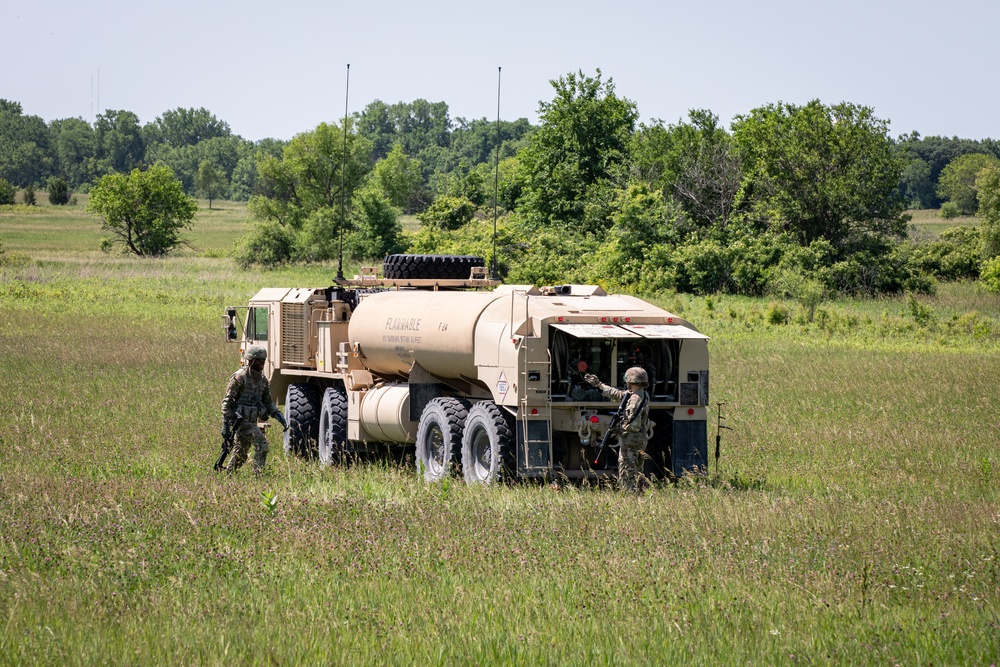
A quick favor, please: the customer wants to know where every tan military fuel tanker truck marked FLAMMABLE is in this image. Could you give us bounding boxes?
[223,255,709,484]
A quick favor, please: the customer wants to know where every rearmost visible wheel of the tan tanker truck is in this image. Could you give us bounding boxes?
[462,401,517,484]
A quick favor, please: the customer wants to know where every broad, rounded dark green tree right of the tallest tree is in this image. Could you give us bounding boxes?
[733,100,906,258]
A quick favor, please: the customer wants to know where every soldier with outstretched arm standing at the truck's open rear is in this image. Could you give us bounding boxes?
[583,366,649,492]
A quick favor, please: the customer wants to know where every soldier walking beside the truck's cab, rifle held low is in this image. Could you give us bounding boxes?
[222,347,288,475]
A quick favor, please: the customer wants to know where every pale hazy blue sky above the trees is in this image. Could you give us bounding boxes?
[0,0,1000,139]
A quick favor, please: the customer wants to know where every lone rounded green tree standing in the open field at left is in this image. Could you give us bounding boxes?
[87,165,198,257]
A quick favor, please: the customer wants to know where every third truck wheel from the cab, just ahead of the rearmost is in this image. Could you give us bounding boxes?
[417,396,469,482]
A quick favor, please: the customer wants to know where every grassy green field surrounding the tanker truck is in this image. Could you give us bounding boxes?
[0,203,1000,665]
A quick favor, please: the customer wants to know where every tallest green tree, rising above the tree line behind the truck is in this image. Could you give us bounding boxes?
[519,70,638,231]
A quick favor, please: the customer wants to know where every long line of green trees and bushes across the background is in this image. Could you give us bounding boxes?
[0,71,1000,300]
